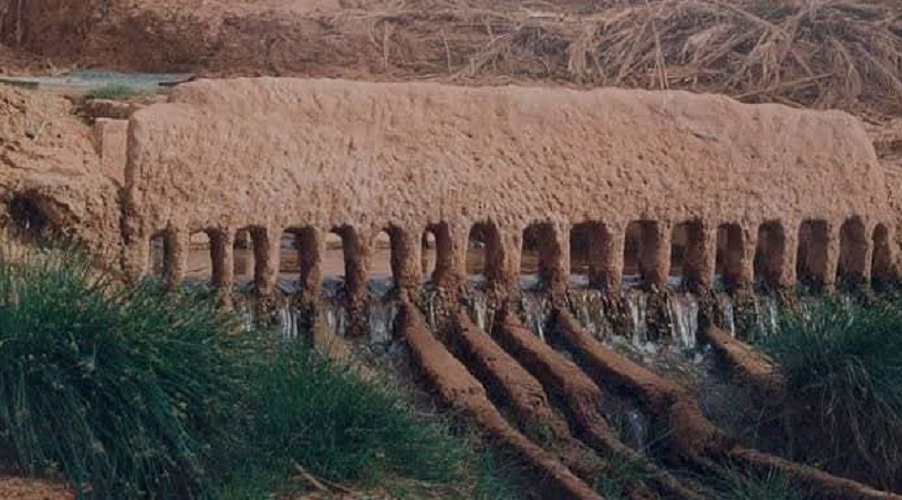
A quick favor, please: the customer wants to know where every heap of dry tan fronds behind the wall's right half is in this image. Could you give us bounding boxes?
[370,0,902,118]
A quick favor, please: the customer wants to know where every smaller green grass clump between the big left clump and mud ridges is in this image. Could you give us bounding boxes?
[218,343,471,486]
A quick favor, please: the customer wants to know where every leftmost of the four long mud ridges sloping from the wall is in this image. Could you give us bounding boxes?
[399,301,601,499]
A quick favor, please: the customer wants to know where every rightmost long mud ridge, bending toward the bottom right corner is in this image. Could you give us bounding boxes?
[555,310,902,500]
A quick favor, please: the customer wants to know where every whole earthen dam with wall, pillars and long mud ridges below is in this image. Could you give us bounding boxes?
[63,78,902,498]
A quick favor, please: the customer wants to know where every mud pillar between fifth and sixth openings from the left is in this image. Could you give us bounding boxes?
[340,226,378,338]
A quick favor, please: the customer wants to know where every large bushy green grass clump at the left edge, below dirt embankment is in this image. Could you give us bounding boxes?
[0,251,252,498]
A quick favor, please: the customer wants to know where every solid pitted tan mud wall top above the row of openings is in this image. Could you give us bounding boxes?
[127,79,888,231]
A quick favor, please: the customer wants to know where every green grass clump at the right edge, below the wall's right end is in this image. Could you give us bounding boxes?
[763,298,902,490]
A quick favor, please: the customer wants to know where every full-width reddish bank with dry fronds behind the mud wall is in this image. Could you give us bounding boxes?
[0,0,902,120]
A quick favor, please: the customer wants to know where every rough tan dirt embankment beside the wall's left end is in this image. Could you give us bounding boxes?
[0,87,120,256]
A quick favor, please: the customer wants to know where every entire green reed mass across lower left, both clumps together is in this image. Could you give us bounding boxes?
[0,250,518,499]
